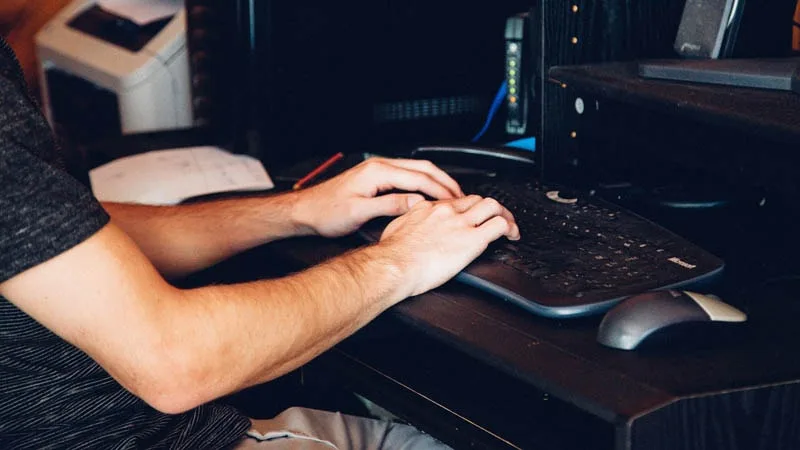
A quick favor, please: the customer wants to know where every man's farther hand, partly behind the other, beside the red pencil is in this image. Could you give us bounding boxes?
[295,158,464,237]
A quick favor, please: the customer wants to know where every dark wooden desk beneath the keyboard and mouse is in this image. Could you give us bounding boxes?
[260,238,800,450]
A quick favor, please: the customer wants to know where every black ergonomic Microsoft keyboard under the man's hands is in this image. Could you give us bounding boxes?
[362,182,724,317]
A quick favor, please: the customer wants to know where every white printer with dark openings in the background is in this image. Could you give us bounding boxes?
[36,0,192,142]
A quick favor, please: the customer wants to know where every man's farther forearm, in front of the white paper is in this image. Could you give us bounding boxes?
[103,193,309,277]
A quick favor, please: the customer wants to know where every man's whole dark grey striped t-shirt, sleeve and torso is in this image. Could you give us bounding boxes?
[0,38,250,450]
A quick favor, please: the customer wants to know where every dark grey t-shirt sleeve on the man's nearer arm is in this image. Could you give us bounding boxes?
[0,133,109,282]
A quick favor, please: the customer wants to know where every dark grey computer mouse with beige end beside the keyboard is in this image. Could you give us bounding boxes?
[597,289,747,350]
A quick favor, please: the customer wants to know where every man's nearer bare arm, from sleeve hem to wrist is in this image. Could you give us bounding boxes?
[0,224,406,413]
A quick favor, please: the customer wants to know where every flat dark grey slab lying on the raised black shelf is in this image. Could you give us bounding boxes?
[639,58,800,94]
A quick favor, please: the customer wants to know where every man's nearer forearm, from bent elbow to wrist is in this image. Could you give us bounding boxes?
[139,241,406,412]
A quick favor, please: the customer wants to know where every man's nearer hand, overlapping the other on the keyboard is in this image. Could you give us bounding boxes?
[377,195,520,296]
